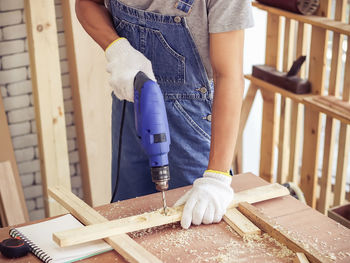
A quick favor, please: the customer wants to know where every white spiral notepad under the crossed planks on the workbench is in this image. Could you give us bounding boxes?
[10,214,112,263]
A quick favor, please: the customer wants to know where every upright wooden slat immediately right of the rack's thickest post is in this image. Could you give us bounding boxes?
[317,0,347,214]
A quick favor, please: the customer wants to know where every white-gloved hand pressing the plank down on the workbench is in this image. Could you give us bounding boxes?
[174,170,233,229]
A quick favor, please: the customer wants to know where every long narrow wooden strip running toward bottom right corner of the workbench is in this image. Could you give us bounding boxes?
[238,203,333,263]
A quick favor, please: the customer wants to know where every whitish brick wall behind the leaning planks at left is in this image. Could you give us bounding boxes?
[0,0,83,223]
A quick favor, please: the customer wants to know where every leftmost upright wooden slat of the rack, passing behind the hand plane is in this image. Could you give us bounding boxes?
[259,13,281,182]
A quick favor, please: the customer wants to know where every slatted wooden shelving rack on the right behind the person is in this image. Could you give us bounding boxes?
[238,0,350,210]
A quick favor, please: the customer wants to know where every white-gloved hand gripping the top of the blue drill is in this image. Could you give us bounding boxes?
[105,38,156,102]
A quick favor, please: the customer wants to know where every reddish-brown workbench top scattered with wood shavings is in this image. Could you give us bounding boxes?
[0,174,350,263]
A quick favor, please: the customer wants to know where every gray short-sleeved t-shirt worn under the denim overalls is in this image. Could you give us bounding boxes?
[106,0,254,79]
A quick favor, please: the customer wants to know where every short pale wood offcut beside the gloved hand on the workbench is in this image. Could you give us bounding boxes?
[223,208,261,237]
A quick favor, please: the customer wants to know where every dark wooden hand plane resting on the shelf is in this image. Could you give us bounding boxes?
[252,56,311,94]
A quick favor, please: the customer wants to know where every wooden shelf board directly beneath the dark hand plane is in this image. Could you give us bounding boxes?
[245,75,350,124]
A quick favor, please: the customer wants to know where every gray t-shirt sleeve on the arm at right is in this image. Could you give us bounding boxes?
[208,0,254,33]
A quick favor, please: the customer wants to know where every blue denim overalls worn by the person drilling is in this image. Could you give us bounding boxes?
[109,0,213,201]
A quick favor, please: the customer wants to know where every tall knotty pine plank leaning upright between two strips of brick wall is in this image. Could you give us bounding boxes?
[25,0,70,219]
